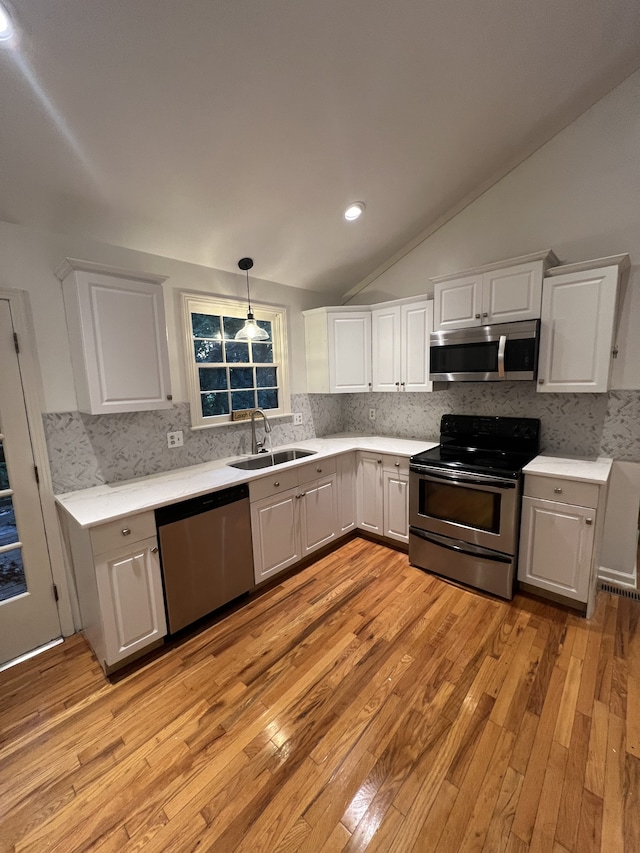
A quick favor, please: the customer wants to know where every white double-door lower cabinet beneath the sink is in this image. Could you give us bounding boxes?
[249,459,338,583]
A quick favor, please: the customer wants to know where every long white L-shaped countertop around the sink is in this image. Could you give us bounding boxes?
[56,434,438,527]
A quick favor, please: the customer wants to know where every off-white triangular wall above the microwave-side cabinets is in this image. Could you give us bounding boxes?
[351,71,640,389]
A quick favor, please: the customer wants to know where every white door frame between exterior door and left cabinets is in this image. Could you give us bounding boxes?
[0,288,74,637]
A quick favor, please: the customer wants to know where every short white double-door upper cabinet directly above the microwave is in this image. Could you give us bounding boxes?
[431,251,558,331]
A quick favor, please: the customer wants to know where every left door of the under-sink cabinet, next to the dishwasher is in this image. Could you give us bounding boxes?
[251,487,302,583]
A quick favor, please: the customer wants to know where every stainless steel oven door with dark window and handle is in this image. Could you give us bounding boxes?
[409,465,520,555]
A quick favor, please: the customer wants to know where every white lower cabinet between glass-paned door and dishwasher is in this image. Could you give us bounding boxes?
[61,512,167,672]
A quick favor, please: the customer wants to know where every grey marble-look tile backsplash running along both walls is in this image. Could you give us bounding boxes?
[43,382,640,494]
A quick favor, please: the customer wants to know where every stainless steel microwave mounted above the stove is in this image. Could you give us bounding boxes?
[429,320,540,382]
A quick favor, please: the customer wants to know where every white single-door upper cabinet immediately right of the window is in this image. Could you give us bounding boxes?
[302,306,371,394]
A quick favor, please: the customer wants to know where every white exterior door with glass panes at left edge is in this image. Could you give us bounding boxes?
[0,299,61,663]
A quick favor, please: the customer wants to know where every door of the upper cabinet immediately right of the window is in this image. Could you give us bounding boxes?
[328,311,371,393]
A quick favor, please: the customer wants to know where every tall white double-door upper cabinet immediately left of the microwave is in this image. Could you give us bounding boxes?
[371,298,433,391]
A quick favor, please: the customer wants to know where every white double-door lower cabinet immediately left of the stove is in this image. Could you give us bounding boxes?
[358,452,409,543]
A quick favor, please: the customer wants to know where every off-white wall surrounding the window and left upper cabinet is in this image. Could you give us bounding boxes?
[0,222,324,412]
